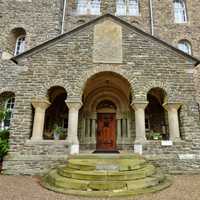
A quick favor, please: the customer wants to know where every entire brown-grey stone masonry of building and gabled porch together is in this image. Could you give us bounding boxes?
[0,0,200,174]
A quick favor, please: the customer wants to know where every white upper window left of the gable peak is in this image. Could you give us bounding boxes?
[77,0,101,15]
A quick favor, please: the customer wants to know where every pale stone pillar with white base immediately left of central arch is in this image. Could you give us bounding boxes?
[66,100,82,155]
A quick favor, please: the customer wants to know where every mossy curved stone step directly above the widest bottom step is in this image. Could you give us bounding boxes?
[58,164,155,181]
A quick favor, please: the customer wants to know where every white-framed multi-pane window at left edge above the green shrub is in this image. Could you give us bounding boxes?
[0,97,15,129]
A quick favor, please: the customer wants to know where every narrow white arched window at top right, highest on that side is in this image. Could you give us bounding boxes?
[174,0,187,23]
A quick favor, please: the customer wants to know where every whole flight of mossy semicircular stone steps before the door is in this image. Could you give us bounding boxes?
[42,155,170,197]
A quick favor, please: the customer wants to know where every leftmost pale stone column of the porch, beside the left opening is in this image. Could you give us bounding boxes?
[31,99,51,140]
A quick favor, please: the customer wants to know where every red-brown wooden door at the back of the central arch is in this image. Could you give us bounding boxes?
[96,113,116,151]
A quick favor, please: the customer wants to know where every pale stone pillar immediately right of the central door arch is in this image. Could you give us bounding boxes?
[132,101,148,144]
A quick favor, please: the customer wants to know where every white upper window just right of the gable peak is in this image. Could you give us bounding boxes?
[116,0,139,16]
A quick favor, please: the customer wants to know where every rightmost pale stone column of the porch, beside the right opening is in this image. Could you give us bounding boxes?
[163,102,182,141]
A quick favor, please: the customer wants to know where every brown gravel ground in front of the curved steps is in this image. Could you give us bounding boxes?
[0,175,200,200]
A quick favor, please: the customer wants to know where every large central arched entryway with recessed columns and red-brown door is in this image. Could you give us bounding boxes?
[79,72,135,151]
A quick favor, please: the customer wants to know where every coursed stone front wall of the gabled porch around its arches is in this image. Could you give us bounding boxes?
[0,17,200,174]
